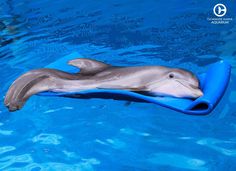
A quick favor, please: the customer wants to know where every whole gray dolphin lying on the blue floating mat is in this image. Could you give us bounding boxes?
[4,58,203,111]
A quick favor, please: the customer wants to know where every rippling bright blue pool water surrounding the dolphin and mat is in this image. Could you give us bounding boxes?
[0,0,236,171]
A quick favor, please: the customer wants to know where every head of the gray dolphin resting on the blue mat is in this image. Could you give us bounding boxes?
[153,68,203,99]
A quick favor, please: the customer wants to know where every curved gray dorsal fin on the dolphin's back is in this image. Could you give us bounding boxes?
[68,58,111,75]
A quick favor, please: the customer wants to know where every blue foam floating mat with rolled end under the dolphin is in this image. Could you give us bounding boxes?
[38,53,231,115]
